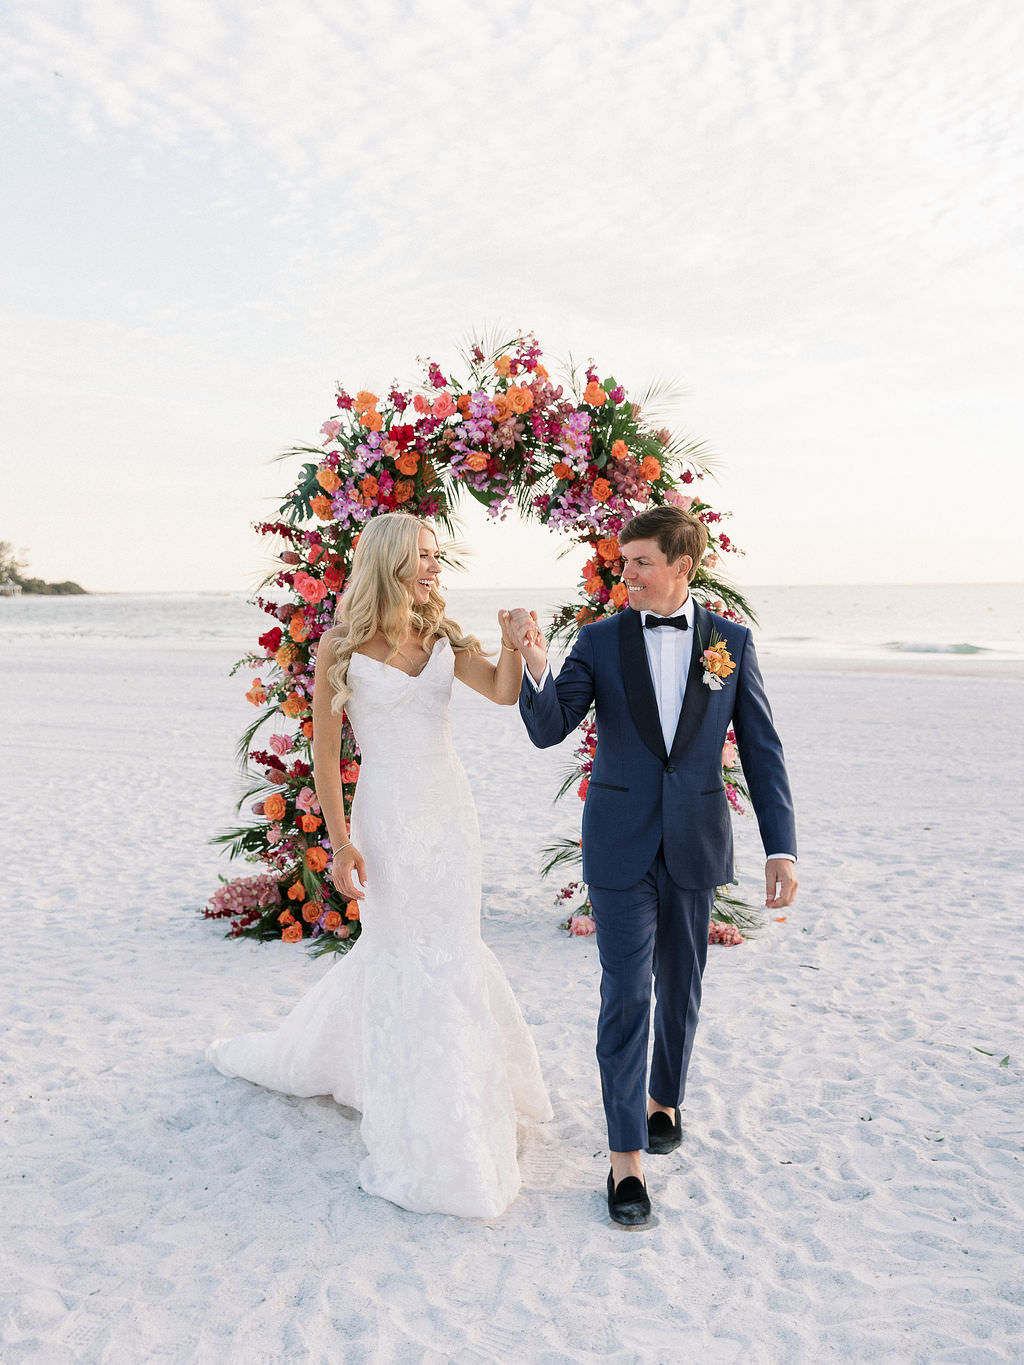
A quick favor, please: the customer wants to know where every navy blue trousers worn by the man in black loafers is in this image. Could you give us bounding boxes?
[590,849,715,1152]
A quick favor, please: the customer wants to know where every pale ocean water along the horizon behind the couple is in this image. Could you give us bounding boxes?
[0,583,1024,667]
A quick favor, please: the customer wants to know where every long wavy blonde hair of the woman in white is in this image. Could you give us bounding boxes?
[328,512,485,715]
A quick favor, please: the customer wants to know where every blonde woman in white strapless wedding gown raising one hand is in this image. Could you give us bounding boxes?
[206,512,552,1218]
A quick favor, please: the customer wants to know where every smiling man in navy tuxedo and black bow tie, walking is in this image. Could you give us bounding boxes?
[511,506,796,1226]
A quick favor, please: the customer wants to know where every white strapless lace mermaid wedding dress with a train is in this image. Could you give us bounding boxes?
[206,640,552,1218]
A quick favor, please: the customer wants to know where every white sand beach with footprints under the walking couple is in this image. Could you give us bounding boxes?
[0,639,1024,1365]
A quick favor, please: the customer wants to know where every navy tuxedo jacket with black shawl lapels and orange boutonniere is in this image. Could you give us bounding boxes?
[519,603,796,890]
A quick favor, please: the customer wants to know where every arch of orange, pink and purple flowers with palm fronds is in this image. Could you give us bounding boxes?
[203,334,748,951]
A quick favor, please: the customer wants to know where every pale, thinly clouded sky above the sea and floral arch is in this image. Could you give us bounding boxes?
[0,0,1024,591]
